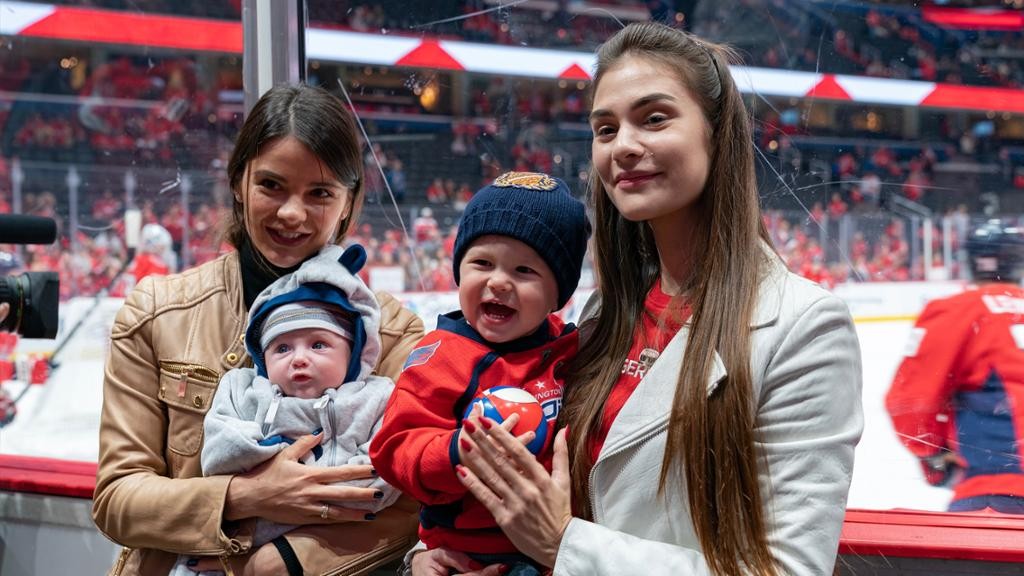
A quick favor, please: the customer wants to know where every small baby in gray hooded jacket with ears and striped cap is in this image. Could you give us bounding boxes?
[171,245,399,576]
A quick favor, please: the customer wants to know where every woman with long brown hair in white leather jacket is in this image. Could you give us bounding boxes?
[423,23,863,576]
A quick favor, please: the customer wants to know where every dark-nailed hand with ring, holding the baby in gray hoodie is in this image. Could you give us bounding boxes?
[224,435,385,525]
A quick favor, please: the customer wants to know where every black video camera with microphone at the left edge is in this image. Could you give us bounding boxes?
[0,214,60,338]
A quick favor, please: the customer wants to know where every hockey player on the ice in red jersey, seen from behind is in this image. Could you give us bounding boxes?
[886,220,1024,513]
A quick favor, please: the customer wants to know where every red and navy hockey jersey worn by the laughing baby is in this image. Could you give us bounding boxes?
[370,312,579,553]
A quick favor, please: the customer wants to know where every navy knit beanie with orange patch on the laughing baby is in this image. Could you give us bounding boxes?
[452,172,590,310]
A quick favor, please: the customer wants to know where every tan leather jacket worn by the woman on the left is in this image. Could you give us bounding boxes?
[92,252,423,575]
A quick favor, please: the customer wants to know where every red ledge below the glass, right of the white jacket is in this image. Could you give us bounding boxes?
[839,510,1024,562]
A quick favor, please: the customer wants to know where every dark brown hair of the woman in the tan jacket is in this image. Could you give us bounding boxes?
[226,84,364,248]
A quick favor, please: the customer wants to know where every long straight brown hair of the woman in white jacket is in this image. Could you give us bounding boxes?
[562,23,778,576]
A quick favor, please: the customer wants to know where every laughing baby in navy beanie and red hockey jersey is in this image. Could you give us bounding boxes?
[370,172,590,575]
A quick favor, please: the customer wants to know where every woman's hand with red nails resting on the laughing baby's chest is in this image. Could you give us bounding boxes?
[457,417,572,567]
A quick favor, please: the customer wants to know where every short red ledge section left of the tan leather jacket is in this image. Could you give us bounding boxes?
[0,454,96,498]
